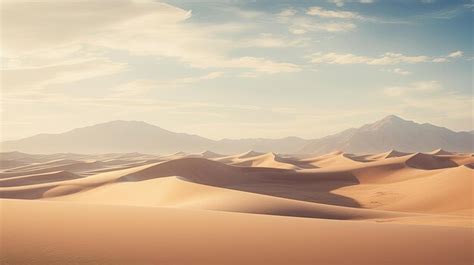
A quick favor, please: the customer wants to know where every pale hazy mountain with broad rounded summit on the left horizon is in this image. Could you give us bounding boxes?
[2,121,213,153]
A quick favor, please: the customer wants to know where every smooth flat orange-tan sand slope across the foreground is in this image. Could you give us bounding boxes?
[0,200,473,264]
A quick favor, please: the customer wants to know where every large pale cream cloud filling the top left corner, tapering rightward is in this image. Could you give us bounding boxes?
[1,0,191,54]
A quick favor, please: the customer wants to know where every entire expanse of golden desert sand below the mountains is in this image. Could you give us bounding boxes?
[0,150,474,264]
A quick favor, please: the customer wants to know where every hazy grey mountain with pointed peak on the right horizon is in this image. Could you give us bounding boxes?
[299,115,474,153]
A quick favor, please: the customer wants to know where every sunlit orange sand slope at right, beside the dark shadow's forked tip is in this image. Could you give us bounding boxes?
[333,166,474,214]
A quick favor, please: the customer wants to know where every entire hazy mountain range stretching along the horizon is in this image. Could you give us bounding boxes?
[1,115,474,154]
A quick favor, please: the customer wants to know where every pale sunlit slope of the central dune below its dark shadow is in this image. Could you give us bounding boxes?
[53,174,409,220]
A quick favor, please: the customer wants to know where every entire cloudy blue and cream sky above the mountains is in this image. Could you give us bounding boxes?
[0,0,474,140]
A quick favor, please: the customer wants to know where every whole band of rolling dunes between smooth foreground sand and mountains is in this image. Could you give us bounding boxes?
[0,150,473,224]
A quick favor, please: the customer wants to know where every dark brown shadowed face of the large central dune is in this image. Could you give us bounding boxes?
[118,158,361,208]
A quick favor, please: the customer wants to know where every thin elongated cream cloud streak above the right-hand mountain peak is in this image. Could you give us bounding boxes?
[310,51,462,65]
